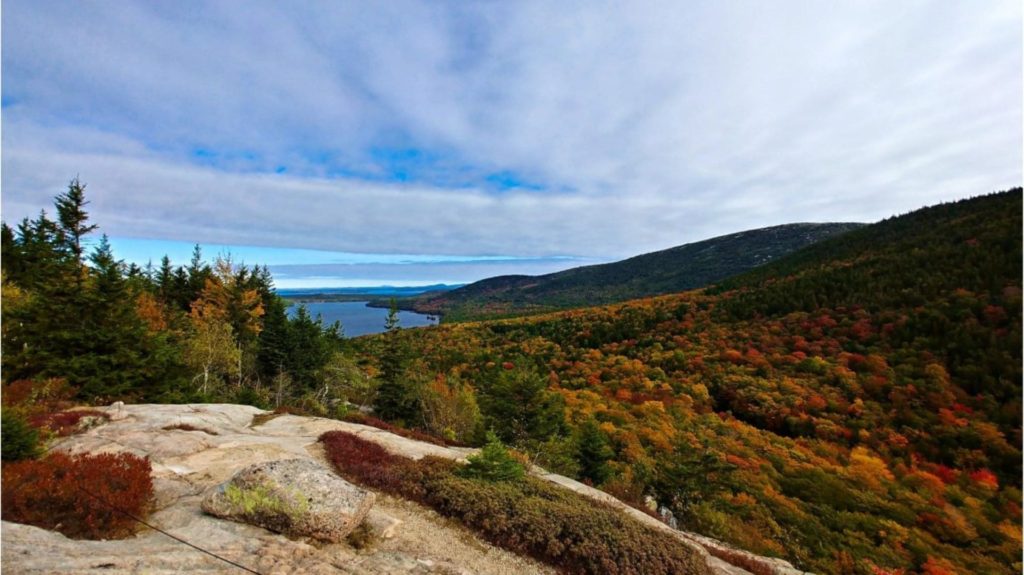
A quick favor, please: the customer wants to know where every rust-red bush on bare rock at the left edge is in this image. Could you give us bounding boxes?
[2,453,153,539]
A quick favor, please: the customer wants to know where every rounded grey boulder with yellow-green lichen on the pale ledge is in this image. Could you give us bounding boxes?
[203,459,376,542]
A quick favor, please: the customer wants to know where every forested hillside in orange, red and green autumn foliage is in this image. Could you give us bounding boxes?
[350,188,1022,575]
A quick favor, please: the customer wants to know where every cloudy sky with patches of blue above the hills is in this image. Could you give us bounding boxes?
[0,0,1024,288]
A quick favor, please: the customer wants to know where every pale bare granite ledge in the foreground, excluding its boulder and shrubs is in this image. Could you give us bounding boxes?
[0,404,801,575]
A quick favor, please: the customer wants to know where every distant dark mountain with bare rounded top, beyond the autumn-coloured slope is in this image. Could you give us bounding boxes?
[402,223,862,321]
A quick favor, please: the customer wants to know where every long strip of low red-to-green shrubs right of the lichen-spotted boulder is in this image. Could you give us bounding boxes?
[321,432,707,575]
